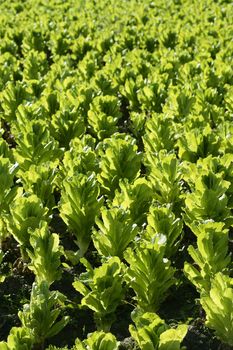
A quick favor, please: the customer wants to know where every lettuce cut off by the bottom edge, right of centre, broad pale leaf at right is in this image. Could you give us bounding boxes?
[129,310,188,350]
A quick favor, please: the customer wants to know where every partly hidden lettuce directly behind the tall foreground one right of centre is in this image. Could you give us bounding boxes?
[145,205,183,258]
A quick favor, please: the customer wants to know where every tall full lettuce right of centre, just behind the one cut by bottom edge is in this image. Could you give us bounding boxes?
[124,241,176,312]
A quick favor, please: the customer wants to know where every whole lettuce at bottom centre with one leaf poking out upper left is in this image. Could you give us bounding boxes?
[73,257,124,331]
